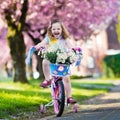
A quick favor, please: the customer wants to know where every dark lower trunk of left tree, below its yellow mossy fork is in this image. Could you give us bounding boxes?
[8,33,28,83]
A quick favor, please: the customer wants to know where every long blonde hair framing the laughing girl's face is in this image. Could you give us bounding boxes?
[47,19,69,39]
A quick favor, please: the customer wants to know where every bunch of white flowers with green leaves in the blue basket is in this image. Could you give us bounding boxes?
[42,47,78,65]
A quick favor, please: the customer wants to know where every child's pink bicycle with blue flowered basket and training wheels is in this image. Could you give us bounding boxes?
[40,47,82,117]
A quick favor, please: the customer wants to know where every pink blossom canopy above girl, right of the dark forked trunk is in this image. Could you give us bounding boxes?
[26,0,120,39]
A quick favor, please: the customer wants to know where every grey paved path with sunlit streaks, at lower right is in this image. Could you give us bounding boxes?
[41,81,120,120]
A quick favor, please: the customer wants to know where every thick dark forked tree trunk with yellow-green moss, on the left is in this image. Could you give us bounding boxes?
[5,0,28,83]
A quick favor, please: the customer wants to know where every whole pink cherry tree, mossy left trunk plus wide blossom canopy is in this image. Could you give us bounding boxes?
[0,0,120,82]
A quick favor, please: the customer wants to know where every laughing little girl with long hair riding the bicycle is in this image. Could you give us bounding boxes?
[26,20,77,104]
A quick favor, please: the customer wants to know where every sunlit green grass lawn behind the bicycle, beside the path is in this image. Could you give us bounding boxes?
[0,79,113,120]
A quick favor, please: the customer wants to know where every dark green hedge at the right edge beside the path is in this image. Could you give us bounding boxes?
[103,54,120,78]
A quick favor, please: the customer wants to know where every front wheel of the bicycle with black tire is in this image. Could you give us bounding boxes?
[54,80,65,117]
